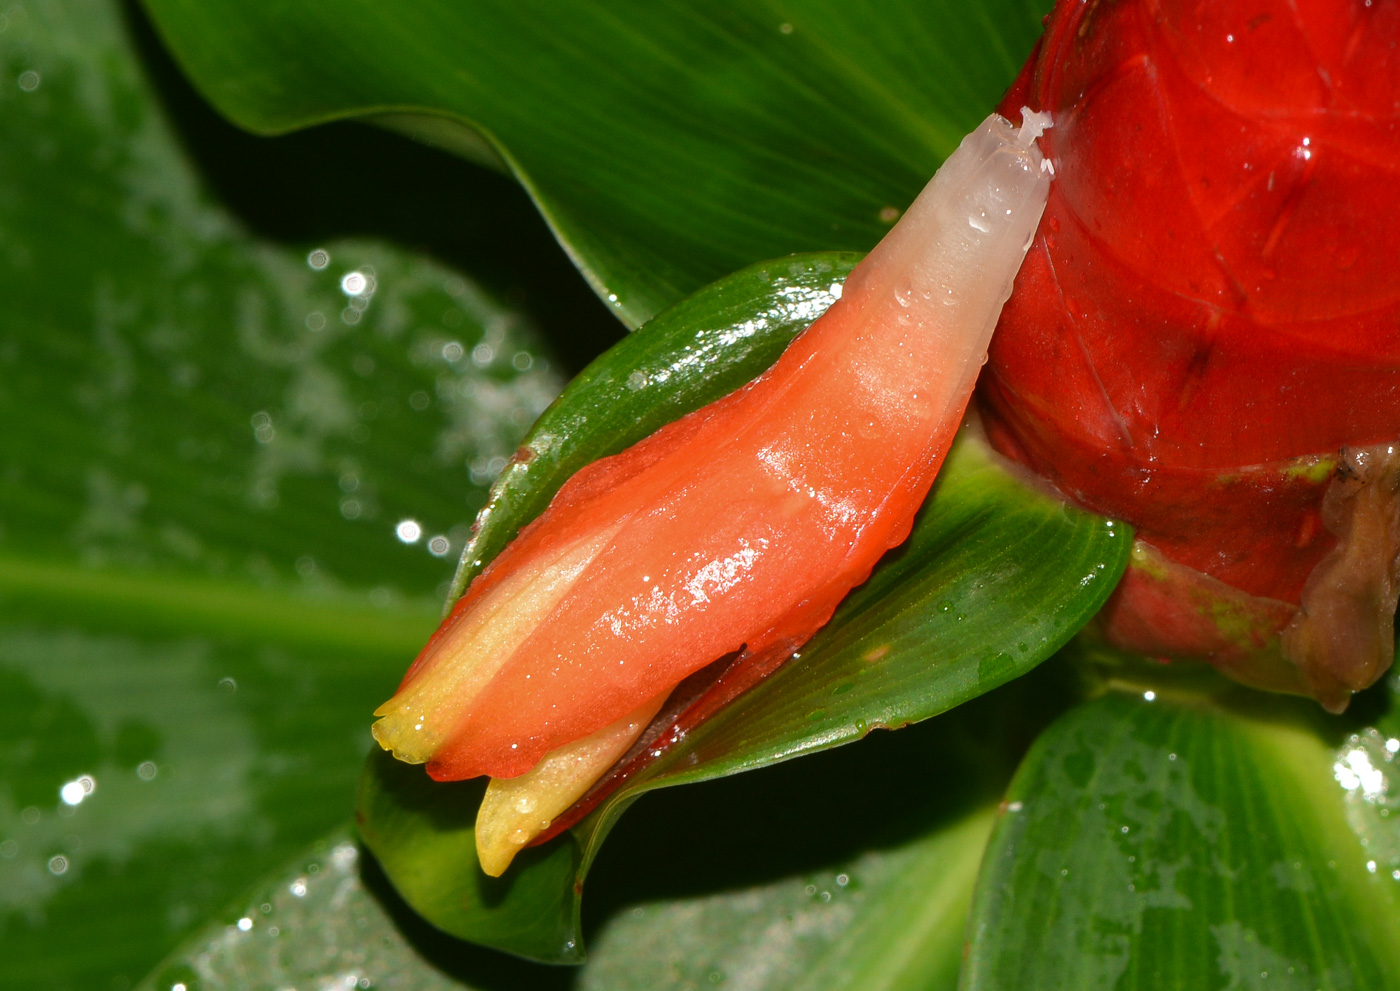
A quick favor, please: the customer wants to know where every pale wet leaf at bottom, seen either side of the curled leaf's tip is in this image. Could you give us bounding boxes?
[143,772,994,991]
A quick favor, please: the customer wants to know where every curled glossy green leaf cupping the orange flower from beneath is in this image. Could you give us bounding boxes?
[358,255,1131,962]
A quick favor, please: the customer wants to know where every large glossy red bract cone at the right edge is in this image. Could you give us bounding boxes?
[980,0,1400,708]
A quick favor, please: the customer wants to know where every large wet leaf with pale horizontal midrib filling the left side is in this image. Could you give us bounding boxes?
[0,0,596,991]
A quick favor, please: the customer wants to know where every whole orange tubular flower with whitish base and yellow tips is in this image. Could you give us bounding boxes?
[374,112,1050,873]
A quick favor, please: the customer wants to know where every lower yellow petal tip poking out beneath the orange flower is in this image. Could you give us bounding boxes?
[476,691,669,878]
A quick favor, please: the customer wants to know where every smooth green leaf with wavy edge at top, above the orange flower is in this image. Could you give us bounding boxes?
[144,0,1047,325]
